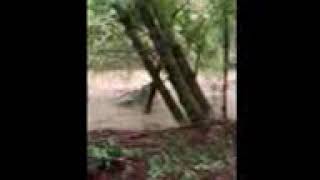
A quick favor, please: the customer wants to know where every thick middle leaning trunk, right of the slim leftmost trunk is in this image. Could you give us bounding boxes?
[139,3,206,121]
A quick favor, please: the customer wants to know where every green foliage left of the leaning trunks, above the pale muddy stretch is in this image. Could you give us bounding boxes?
[87,0,140,70]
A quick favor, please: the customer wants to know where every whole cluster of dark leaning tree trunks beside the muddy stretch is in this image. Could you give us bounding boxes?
[115,0,215,124]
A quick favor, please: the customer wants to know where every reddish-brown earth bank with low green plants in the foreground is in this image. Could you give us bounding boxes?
[89,121,236,180]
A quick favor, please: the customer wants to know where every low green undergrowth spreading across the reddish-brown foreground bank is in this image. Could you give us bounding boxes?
[88,127,231,180]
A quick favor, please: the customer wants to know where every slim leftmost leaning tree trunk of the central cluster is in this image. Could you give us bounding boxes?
[114,5,186,123]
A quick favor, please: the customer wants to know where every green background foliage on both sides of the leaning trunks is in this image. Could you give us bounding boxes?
[87,0,236,71]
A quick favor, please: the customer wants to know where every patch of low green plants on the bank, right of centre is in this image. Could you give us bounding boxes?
[148,134,227,179]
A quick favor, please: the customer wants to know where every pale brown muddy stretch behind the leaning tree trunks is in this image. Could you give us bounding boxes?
[87,70,236,131]
